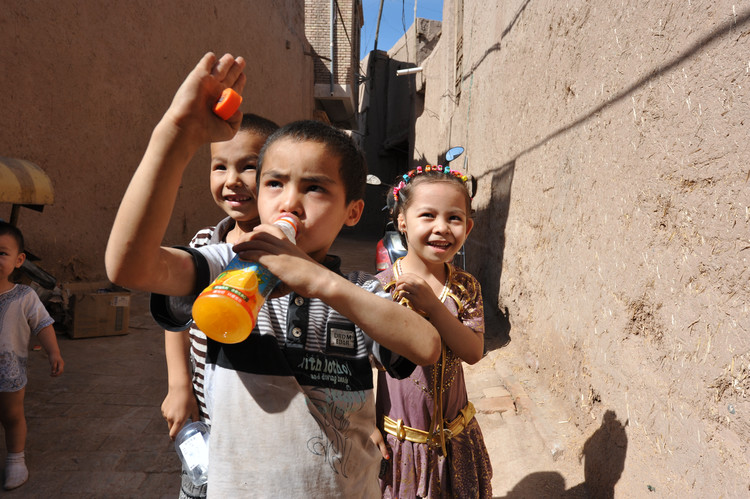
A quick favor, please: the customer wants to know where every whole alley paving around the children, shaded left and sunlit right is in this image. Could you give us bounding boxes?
[5,237,585,498]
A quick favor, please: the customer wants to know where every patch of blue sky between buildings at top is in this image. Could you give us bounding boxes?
[359,0,443,60]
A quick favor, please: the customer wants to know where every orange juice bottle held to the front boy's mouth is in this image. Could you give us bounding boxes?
[193,213,299,343]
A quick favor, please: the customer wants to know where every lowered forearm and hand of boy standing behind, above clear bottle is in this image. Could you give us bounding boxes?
[161,330,200,440]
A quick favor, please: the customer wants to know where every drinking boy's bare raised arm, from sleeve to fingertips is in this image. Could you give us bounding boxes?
[105,53,245,296]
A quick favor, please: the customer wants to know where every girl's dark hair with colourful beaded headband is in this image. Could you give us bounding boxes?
[387,165,471,227]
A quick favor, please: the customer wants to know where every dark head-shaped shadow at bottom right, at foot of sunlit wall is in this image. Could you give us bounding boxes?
[501,410,628,499]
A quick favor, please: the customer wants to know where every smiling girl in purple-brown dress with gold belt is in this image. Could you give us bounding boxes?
[377,165,492,498]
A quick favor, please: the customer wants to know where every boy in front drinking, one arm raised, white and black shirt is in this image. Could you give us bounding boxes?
[106,54,440,497]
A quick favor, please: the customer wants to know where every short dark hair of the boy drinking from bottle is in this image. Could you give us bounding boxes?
[258,120,367,203]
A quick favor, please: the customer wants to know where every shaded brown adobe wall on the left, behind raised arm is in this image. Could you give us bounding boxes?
[0,0,313,281]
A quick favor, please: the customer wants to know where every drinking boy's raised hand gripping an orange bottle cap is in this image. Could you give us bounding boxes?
[164,52,246,144]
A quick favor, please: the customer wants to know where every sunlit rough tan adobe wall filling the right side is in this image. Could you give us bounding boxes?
[415,0,750,497]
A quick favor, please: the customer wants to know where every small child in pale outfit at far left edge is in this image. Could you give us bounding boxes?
[0,221,64,490]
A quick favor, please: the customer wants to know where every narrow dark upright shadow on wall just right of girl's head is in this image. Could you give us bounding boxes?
[466,160,516,348]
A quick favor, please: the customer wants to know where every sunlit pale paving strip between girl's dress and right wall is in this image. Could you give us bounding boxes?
[464,344,587,499]
